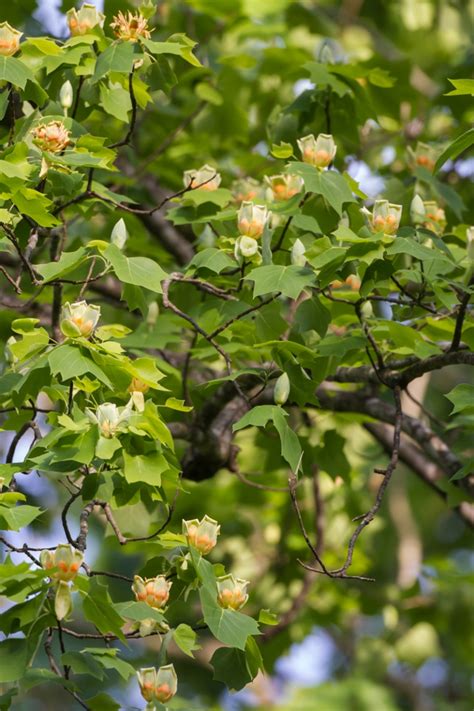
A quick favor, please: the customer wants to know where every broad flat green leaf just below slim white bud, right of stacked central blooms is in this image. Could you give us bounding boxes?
[245,264,316,299]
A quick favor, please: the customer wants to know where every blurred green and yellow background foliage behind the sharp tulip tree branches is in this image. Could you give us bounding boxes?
[1,0,474,711]
